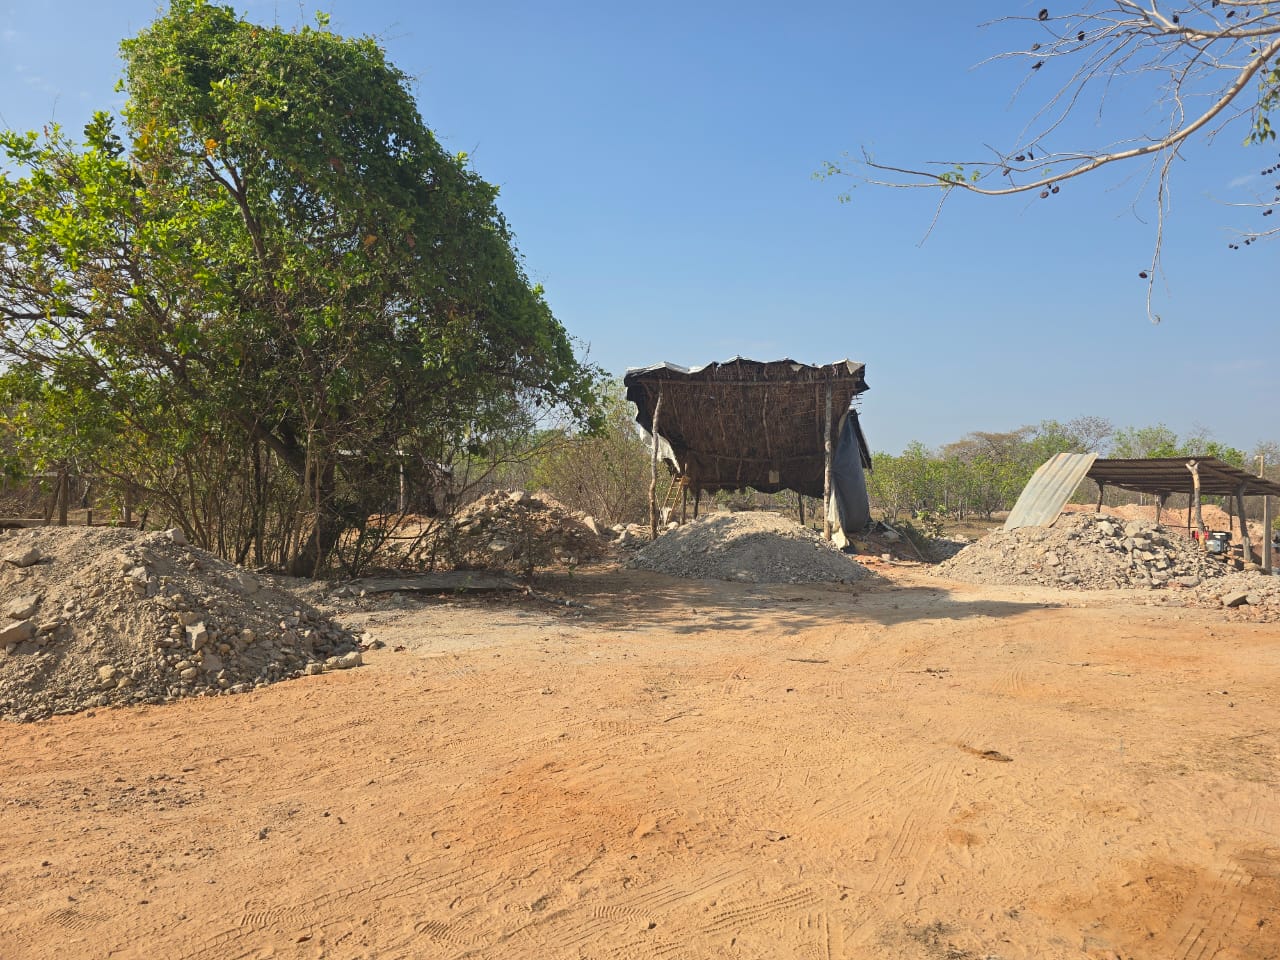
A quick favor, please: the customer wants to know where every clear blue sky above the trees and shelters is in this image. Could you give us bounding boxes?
[0,0,1280,452]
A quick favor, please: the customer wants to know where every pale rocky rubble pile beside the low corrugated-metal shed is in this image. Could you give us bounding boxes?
[936,513,1228,590]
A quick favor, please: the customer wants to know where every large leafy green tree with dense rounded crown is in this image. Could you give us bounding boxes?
[0,0,595,573]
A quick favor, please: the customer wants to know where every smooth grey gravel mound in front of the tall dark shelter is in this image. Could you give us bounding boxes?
[630,512,870,584]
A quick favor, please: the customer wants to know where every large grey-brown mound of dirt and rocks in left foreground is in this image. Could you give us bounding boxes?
[0,527,360,719]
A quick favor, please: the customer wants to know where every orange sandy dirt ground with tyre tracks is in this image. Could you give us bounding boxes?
[0,564,1280,960]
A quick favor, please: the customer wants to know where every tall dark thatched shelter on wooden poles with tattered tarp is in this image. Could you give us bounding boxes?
[623,357,870,542]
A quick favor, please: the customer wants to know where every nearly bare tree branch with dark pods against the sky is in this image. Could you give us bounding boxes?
[818,0,1280,320]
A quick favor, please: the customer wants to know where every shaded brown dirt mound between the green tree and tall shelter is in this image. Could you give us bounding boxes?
[439,490,607,571]
